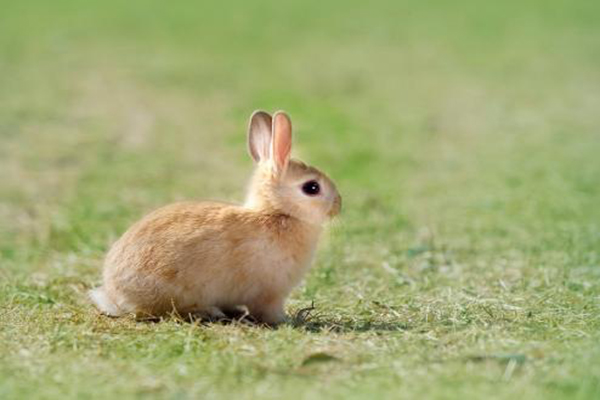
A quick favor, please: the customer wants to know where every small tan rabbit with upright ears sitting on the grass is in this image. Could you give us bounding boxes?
[90,111,342,325]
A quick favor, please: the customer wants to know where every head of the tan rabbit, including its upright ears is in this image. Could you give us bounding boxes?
[246,111,342,225]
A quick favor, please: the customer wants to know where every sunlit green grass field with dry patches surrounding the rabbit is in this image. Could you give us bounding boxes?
[0,0,600,400]
